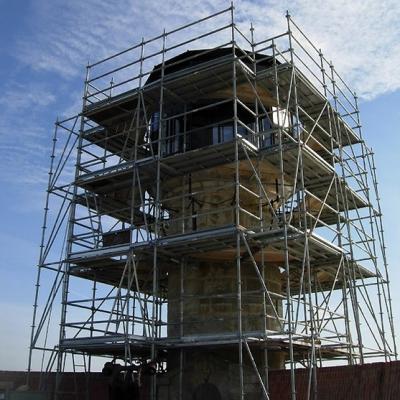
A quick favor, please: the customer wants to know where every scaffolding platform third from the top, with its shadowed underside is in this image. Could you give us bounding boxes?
[68,223,375,292]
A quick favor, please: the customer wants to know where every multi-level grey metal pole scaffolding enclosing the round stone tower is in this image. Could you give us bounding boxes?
[28,5,397,400]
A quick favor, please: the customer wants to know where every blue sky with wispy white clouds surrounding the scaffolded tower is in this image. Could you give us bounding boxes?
[0,0,400,369]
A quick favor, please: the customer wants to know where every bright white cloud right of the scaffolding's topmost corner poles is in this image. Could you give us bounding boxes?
[268,0,400,99]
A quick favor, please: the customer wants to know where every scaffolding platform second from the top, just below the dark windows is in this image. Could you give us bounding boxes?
[75,138,335,193]
